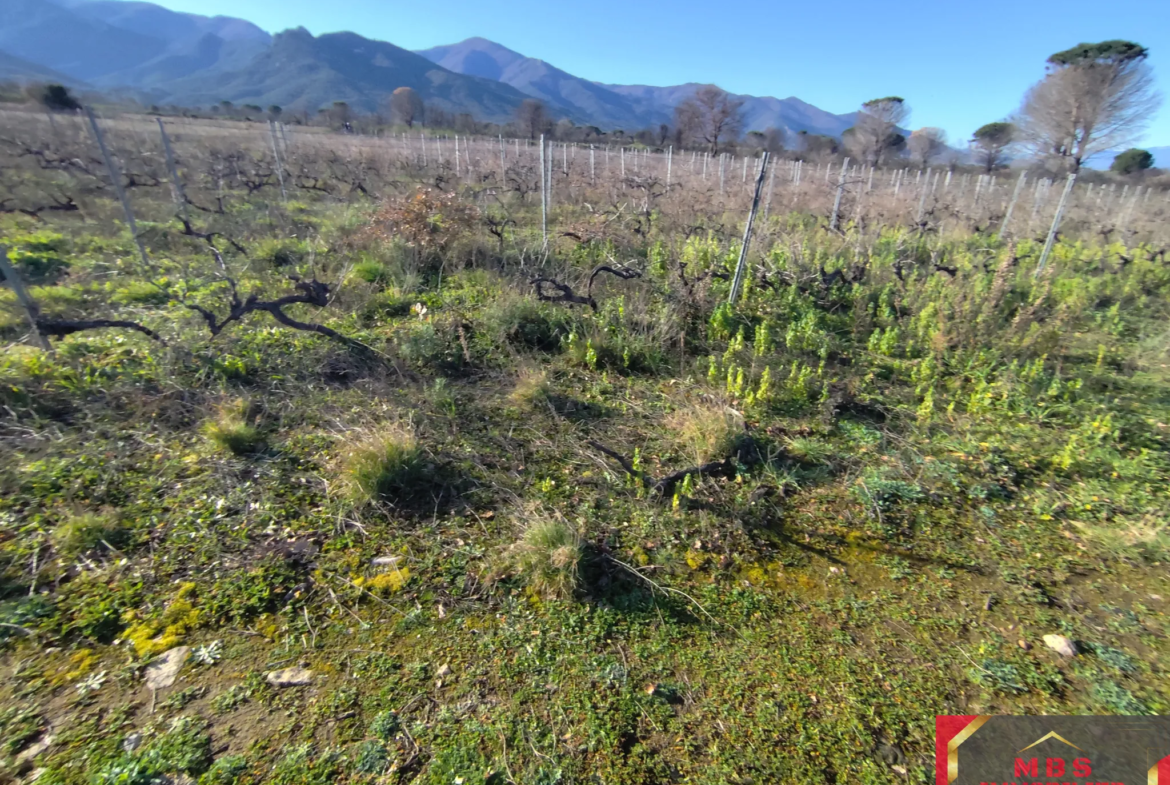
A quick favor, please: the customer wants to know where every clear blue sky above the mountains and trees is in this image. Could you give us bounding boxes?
[143,0,1170,146]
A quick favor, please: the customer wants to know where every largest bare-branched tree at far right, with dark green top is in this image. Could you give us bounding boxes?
[1016,41,1161,172]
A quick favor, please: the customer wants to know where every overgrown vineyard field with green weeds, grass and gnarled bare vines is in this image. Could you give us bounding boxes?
[0,112,1170,785]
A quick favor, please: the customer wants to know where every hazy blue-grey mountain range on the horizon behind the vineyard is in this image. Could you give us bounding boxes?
[0,0,875,136]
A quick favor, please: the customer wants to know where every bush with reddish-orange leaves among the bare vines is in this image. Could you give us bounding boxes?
[370,188,480,262]
